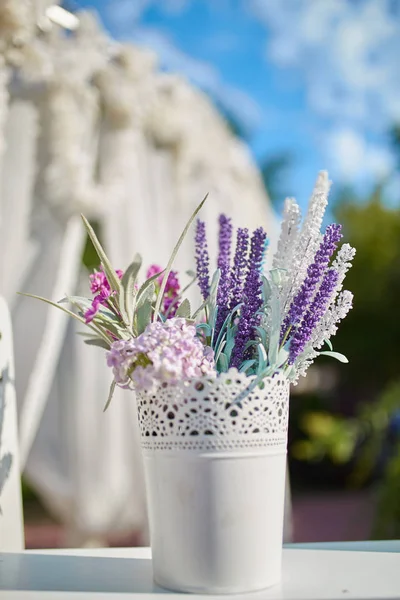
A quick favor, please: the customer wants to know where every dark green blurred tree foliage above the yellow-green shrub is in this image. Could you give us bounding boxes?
[334,187,400,401]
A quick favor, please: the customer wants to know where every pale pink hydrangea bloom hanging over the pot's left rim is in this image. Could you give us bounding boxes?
[107,318,215,392]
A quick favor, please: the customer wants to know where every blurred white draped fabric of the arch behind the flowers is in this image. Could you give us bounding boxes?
[0,3,282,544]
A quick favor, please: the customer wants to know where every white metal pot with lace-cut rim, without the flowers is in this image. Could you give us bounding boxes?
[137,370,289,594]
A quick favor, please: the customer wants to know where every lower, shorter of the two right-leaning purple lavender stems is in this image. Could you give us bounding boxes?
[288,269,339,365]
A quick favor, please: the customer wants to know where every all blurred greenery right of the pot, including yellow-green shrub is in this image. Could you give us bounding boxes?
[290,128,400,539]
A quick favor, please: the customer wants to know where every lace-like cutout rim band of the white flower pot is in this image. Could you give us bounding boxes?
[137,369,289,450]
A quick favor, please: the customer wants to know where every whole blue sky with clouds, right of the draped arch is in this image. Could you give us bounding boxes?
[75,0,400,210]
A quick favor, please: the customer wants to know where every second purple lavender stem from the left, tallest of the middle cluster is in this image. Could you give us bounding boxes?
[214,215,233,339]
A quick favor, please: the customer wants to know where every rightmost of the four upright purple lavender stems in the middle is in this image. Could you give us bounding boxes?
[230,227,267,369]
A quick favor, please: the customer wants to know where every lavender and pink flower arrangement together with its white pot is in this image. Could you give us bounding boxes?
[24,172,355,593]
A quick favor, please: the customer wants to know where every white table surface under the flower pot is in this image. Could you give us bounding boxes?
[0,548,400,600]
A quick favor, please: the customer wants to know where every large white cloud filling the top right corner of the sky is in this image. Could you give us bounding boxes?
[250,0,400,129]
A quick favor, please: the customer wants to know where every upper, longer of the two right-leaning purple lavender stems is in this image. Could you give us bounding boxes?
[281,223,342,342]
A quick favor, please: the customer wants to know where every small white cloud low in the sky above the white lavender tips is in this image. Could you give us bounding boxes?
[326,128,394,182]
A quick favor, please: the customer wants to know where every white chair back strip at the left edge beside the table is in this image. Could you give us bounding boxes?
[0,298,24,552]
